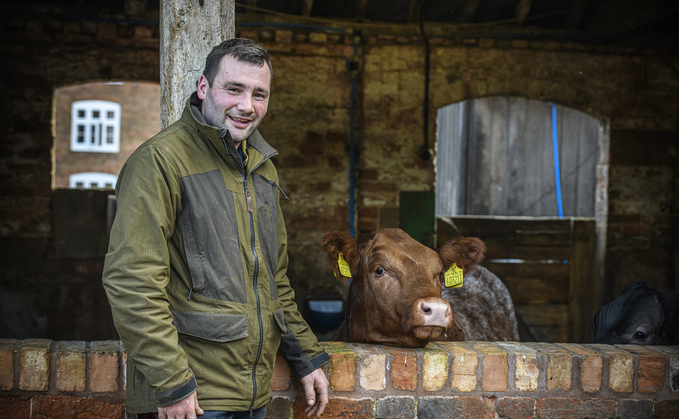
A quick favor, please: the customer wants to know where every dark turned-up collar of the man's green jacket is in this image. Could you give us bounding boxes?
[182,92,278,167]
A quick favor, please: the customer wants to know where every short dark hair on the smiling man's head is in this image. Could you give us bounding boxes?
[203,38,273,86]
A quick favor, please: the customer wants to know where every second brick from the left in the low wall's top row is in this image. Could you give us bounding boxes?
[19,339,52,391]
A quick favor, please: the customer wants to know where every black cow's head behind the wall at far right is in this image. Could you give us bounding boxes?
[594,280,665,345]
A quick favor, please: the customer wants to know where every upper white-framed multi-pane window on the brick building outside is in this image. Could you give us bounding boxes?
[71,100,120,153]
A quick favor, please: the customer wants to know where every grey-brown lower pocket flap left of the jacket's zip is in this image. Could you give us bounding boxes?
[172,311,248,342]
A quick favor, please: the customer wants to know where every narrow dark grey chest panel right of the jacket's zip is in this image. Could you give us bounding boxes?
[252,173,278,300]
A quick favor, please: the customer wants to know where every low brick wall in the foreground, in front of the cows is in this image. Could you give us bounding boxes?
[0,339,679,419]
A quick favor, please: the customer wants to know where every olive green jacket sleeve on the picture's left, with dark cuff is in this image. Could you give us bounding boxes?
[103,145,197,406]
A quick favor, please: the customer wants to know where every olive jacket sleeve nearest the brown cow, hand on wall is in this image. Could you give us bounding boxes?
[276,179,330,378]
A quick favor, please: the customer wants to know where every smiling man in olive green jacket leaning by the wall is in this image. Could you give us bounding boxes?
[103,39,329,419]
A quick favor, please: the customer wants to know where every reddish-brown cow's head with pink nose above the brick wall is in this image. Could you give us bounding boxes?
[323,229,453,347]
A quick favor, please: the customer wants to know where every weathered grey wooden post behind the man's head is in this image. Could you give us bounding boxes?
[160,0,236,128]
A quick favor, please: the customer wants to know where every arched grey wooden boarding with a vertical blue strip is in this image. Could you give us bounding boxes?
[436,97,601,217]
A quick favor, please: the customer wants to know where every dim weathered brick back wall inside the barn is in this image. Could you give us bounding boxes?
[0,4,679,340]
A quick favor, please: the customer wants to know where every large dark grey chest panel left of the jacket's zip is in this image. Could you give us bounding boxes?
[180,170,247,303]
